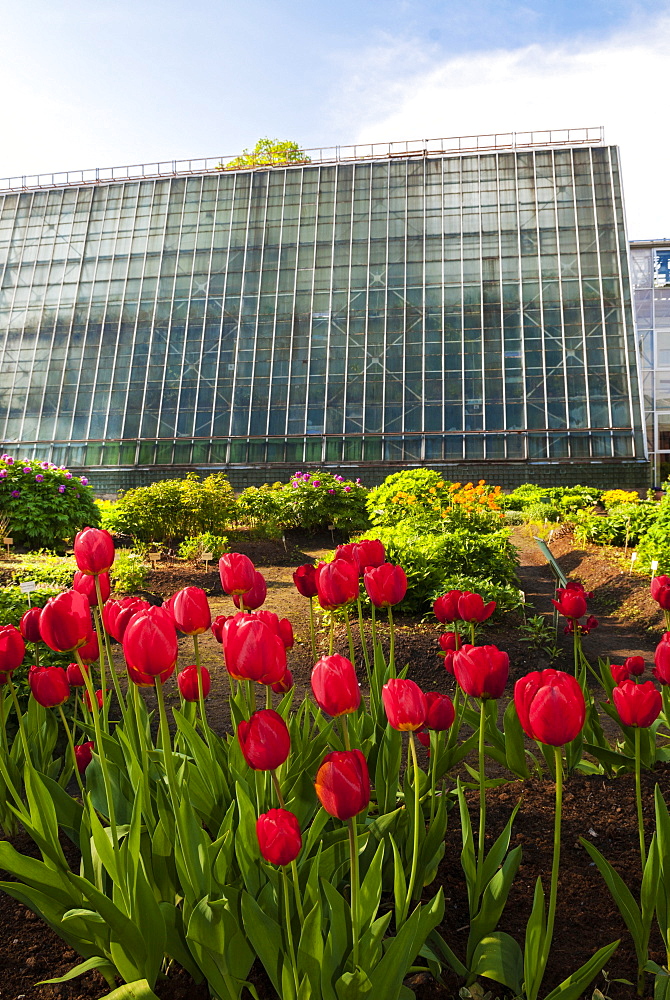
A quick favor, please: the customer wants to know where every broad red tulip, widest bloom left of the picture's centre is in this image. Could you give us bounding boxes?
[222,613,286,684]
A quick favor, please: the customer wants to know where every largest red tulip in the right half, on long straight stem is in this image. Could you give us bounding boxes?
[514,669,586,747]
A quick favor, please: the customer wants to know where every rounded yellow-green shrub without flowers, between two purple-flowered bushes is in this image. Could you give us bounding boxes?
[115,473,236,542]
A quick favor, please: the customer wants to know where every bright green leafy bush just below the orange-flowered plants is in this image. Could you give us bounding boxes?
[361,520,521,612]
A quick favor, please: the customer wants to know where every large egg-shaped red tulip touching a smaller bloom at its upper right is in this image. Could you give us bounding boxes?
[123,607,179,686]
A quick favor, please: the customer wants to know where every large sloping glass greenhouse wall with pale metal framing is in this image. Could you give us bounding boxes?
[0,145,646,485]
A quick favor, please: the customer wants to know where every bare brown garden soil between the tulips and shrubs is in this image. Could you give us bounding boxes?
[0,528,670,1000]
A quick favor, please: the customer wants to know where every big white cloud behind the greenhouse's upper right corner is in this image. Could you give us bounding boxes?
[334,16,670,239]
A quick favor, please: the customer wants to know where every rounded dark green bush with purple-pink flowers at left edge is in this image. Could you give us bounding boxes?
[0,455,100,549]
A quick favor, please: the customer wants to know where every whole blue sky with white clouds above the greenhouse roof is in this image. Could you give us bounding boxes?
[0,0,670,237]
